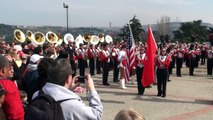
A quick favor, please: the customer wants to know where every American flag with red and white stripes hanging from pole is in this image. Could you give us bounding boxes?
[125,24,135,81]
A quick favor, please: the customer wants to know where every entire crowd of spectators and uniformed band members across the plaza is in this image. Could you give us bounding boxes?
[0,36,213,120]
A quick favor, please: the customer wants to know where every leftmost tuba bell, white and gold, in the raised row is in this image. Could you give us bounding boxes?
[13,29,25,43]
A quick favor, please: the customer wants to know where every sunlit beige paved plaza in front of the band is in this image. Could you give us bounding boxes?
[80,66,213,120]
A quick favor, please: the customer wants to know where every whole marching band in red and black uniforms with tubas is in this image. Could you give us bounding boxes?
[0,30,213,97]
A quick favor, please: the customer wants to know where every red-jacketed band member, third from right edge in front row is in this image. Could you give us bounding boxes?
[188,45,197,75]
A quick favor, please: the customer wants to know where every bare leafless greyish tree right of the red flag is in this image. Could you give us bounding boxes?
[157,16,172,42]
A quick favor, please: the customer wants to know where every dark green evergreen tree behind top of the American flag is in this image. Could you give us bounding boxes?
[121,16,144,42]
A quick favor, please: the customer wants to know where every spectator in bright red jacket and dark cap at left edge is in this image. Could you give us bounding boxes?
[0,55,24,120]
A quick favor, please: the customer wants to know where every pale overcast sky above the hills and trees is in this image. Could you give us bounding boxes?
[0,0,213,27]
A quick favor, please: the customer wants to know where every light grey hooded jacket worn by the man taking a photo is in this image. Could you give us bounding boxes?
[33,83,103,120]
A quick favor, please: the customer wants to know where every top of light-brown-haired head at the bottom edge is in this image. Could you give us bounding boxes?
[114,109,145,120]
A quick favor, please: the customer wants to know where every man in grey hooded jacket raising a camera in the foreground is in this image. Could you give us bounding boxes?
[33,58,103,120]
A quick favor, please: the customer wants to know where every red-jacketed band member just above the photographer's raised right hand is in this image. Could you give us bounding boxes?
[87,44,96,75]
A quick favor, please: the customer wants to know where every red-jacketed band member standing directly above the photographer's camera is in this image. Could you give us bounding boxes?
[77,43,85,76]
